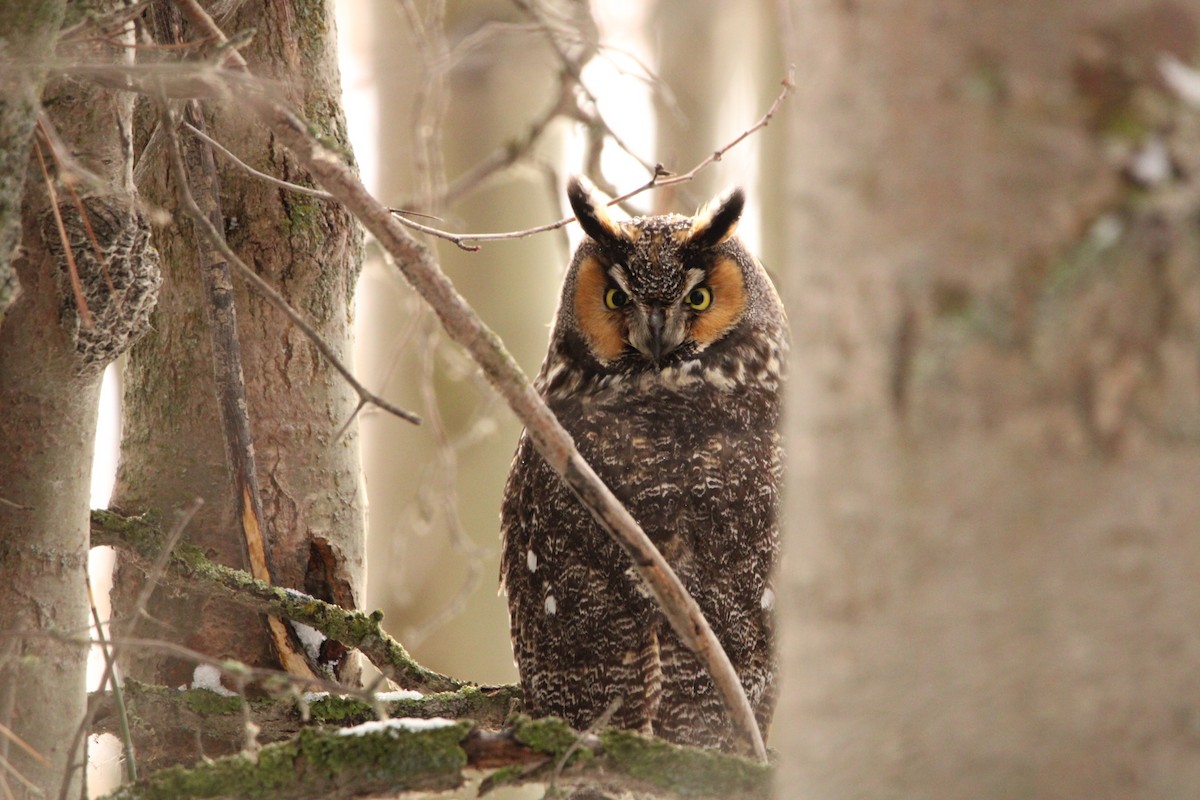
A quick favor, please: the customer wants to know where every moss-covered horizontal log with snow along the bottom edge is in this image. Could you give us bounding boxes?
[108,716,772,800]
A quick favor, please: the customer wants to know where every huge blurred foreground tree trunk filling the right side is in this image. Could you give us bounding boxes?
[776,0,1200,799]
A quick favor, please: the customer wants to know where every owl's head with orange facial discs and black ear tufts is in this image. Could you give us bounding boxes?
[559,178,778,372]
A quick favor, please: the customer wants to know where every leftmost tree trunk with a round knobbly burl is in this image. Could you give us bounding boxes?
[0,4,158,798]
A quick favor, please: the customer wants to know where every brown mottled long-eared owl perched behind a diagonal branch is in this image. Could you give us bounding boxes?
[500,178,787,750]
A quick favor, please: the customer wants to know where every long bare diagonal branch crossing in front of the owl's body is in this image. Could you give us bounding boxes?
[175,0,767,762]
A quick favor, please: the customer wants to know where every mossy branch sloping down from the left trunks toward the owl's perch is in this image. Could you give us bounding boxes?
[91,511,466,692]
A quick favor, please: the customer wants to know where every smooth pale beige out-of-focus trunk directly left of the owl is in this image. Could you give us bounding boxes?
[352,0,565,682]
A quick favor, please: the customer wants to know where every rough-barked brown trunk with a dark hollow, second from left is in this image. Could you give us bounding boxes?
[112,0,364,760]
